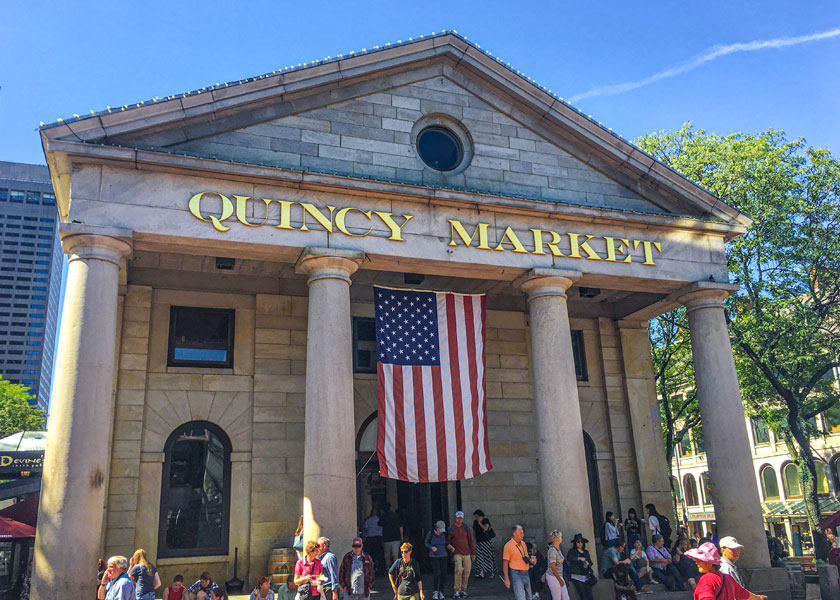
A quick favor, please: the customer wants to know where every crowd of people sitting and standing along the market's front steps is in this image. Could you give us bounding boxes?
[83,504,769,600]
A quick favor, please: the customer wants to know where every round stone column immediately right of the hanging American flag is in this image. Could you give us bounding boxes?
[518,269,597,548]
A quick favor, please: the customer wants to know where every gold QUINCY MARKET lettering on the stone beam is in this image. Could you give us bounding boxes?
[189,192,662,266]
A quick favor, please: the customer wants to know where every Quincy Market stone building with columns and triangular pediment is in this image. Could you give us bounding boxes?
[34,32,786,600]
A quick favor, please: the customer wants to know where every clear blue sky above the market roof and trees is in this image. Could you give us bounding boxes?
[0,0,840,163]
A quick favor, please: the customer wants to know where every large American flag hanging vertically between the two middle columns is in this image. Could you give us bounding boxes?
[373,287,492,482]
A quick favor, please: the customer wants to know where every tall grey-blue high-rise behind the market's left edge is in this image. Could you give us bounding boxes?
[0,161,64,411]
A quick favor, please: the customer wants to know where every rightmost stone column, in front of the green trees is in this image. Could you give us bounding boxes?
[680,282,770,569]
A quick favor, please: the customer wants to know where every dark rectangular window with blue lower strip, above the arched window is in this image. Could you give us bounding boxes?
[167,306,236,368]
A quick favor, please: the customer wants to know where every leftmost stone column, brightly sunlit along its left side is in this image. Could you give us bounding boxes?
[32,225,131,600]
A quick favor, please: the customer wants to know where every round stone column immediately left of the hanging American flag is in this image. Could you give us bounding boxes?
[295,248,364,554]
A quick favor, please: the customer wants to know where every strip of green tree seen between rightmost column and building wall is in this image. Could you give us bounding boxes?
[650,308,700,517]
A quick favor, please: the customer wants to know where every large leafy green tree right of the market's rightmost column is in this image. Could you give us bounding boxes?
[637,124,840,556]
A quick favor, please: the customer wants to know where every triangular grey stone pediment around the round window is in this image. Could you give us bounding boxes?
[37,35,748,230]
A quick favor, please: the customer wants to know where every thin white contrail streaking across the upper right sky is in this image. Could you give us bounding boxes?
[568,27,840,103]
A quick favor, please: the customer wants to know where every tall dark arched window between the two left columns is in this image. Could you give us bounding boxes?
[158,421,231,558]
